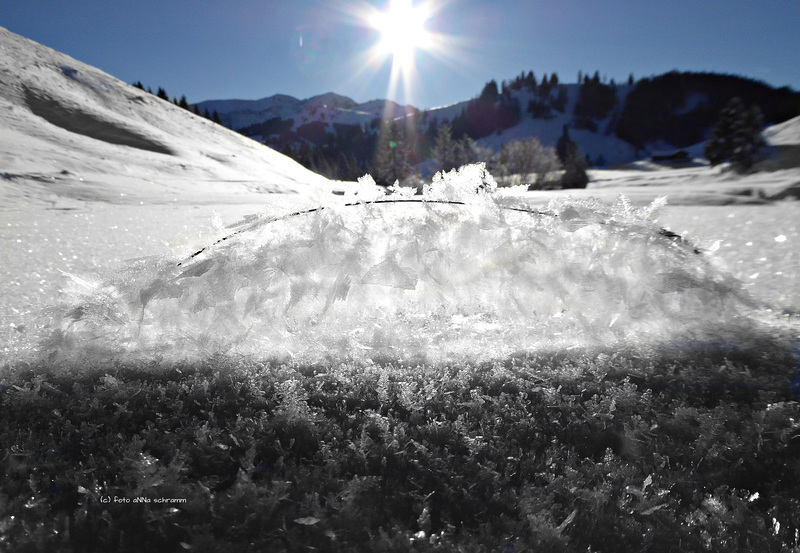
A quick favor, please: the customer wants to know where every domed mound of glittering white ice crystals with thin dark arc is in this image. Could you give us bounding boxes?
[36,165,764,363]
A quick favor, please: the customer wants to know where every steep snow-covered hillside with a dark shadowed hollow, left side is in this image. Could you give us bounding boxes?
[0,27,331,204]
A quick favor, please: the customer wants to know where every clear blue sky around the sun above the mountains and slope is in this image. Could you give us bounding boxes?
[0,0,800,108]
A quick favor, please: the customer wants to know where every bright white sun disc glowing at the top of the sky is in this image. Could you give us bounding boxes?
[371,0,430,69]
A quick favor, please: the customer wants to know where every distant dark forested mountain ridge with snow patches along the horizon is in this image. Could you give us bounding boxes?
[197,71,800,175]
